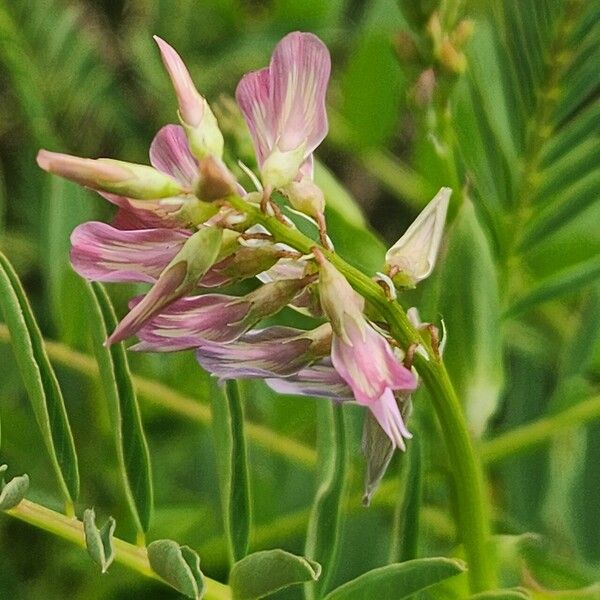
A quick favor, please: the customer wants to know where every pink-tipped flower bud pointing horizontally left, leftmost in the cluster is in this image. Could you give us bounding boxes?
[37,150,185,200]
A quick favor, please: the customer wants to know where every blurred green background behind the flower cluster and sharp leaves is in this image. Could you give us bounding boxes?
[0,0,600,600]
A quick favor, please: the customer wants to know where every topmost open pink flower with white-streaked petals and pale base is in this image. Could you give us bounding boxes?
[236,32,331,187]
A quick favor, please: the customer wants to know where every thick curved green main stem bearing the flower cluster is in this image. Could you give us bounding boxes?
[228,197,496,593]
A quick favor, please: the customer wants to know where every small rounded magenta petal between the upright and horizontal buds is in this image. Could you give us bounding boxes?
[150,125,198,188]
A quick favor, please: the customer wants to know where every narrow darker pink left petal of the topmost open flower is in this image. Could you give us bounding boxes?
[235,68,276,166]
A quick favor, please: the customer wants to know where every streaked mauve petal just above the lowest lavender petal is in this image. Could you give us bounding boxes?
[130,294,253,352]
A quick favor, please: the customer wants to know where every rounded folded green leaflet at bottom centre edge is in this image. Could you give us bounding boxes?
[229,549,321,600]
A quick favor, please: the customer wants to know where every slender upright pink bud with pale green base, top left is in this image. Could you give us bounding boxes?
[154,36,223,159]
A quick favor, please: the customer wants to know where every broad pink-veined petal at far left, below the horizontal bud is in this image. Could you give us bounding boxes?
[71,221,190,283]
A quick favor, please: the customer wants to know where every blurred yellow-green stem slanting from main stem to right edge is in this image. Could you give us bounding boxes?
[481,396,600,464]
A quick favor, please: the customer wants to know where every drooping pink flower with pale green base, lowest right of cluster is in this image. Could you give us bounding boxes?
[315,252,417,449]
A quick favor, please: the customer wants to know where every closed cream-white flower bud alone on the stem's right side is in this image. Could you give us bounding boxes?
[385,188,452,287]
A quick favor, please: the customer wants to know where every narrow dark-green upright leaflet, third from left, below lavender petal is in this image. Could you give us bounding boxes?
[212,381,251,563]
